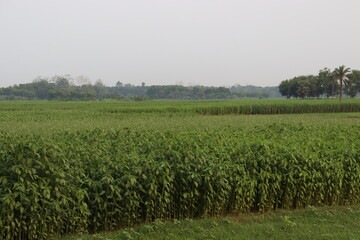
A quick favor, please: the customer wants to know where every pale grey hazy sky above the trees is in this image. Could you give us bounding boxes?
[0,0,360,87]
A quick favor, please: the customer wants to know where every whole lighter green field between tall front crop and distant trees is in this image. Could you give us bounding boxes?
[0,99,360,135]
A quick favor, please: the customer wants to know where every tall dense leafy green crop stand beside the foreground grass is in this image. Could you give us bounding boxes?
[0,124,360,240]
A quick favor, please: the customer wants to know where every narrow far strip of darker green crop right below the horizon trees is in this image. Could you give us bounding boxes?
[0,99,360,116]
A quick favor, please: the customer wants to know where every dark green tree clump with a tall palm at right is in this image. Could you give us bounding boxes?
[279,66,360,101]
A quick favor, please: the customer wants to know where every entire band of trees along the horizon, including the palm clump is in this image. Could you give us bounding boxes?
[0,66,360,101]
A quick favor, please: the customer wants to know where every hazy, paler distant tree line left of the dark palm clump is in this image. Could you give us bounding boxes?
[0,75,281,101]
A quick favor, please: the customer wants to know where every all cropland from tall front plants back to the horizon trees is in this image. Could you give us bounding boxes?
[0,99,360,239]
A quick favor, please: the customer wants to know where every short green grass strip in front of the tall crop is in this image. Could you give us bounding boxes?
[61,205,360,240]
